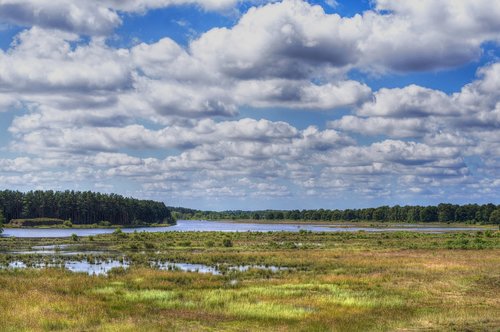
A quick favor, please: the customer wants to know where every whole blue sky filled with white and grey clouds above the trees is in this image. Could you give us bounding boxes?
[0,0,500,210]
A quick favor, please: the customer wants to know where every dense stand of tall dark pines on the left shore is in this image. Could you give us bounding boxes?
[0,190,175,225]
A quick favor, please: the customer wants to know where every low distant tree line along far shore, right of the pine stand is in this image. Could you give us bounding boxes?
[169,203,500,224]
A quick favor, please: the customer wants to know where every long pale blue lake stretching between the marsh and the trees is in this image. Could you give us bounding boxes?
[0,220,484,238]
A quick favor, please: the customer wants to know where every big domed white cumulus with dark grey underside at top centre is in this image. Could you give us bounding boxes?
[190,0,360,79]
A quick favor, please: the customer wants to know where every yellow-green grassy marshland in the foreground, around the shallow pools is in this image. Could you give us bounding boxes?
[0,231,500,331]
